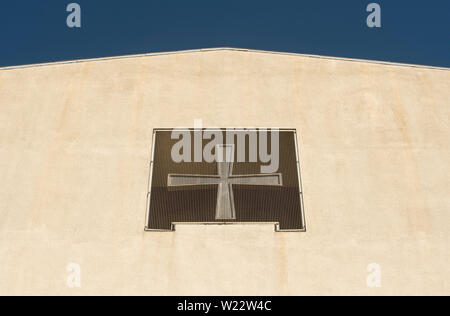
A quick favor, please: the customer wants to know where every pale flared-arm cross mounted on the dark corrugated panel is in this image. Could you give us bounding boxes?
[167,145,283,220]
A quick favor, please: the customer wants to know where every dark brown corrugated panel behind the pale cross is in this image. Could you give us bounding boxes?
[147,130,305,231]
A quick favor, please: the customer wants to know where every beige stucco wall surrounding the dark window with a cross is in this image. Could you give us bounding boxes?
[0,50,450,295]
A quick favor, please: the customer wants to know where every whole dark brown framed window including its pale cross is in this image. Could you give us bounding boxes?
[146,129,306,232]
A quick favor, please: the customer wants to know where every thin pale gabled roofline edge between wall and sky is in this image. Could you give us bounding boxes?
[0,47,450,70]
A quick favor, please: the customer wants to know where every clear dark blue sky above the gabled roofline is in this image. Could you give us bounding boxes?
[0,0,450,67]
